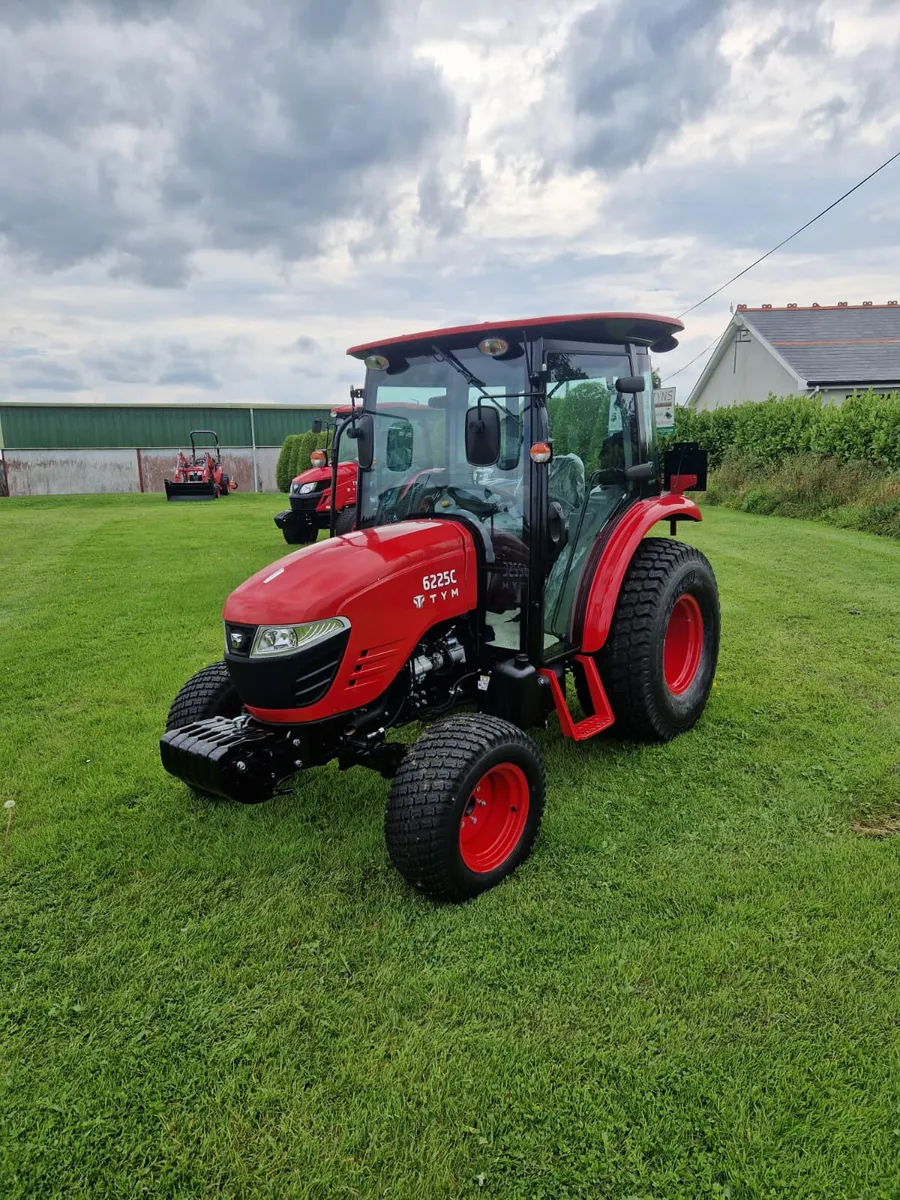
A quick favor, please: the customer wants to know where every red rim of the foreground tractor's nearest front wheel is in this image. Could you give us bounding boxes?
[460,762,529,875]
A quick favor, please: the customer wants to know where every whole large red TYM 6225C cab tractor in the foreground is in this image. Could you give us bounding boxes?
[161,313,719,900]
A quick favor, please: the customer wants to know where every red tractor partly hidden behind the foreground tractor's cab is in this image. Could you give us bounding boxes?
[275,407,359,546]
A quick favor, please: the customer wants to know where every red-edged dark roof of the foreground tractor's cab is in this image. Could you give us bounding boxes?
[347,312,684,359]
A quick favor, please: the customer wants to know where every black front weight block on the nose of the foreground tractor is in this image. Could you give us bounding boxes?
[160,716,306,804]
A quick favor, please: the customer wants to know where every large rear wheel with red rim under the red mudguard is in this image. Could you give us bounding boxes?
[575,538,720,742]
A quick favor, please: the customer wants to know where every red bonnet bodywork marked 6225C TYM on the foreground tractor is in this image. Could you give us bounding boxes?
[223,521,478,725]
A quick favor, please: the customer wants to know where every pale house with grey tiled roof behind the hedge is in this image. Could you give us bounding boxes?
[689,300,900,412]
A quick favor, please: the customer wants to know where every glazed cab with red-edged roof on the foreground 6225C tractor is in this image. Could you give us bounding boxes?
[345,314,682,664]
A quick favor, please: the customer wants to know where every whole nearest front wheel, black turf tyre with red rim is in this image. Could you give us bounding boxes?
[384,715,546,901]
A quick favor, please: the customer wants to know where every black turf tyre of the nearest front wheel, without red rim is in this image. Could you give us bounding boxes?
[384,714,546,901]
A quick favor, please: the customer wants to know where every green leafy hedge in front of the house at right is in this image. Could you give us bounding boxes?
[676,391,900,470]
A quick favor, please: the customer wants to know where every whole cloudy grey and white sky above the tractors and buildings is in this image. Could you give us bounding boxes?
[0,0,900,403]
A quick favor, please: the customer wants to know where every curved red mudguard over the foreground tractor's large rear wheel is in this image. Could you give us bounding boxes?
[581,494,703,654]
